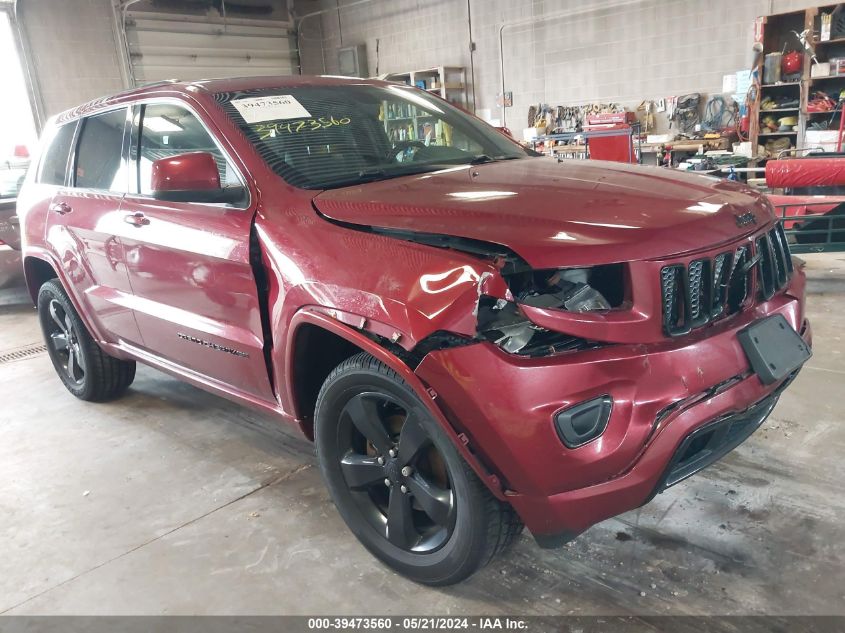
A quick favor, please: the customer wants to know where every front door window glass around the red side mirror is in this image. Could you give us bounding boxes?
[138,103,242,195]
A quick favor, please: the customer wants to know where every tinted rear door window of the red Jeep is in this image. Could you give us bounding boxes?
[74,108,127,193]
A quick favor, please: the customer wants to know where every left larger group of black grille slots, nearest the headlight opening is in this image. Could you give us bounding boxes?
[660,246,749,336]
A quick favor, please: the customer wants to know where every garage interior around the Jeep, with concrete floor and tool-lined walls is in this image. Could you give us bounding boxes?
[0,0,845,616]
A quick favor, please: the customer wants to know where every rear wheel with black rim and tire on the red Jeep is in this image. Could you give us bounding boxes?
[38,279,135,402]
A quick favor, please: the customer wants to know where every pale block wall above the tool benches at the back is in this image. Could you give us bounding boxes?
[294,0,816,128]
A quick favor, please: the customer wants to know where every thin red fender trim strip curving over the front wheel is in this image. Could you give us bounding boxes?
[285,307,506,501]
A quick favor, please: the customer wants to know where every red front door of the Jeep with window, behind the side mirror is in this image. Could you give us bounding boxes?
[121,101,275,402]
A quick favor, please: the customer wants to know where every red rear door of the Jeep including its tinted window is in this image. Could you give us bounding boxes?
[47,106,141,344]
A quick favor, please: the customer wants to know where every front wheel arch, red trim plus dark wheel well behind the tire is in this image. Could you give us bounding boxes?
[285,308,505,500]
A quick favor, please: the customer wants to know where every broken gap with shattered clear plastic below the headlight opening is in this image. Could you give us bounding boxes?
[478,296,600,356]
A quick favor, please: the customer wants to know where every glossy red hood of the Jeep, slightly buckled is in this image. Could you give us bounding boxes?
[314,158,773,268]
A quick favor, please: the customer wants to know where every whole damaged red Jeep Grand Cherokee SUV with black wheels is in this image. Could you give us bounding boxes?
[18,77,810,585]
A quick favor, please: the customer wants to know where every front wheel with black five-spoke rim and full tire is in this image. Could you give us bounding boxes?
[314,353,522,585]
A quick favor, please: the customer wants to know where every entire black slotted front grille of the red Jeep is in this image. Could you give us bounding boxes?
[660,224,792,336]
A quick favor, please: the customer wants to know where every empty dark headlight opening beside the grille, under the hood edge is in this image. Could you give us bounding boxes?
[507,264,625,312]
